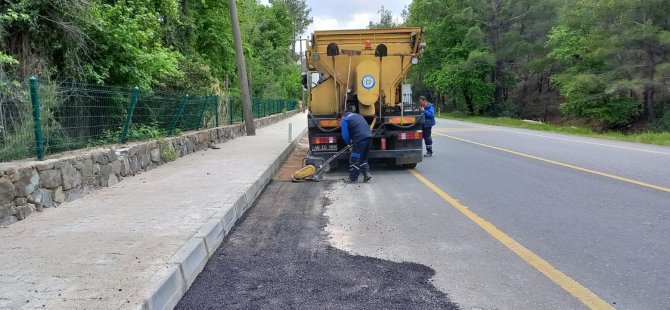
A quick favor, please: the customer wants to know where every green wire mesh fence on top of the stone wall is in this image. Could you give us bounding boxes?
[0,79,298,162]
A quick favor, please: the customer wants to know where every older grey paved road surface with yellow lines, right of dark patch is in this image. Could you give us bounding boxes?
[176,121,670,309]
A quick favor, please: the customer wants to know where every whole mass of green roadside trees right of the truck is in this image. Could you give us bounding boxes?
[407,0,670,128]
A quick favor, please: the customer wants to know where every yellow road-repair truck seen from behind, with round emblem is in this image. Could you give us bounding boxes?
[303,28,424,168]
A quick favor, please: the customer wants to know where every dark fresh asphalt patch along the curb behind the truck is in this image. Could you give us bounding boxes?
[176,181,458,309]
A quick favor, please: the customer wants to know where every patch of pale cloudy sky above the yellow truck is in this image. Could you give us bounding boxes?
[261,0,411,34]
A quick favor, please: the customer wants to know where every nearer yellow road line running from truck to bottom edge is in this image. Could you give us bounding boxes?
[409,169,614,310]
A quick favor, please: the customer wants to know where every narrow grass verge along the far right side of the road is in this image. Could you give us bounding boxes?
[439,112,670,146]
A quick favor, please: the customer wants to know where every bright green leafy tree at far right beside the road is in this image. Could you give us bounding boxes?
[547,0,670,127]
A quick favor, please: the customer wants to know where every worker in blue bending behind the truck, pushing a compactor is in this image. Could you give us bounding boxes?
[339,112,372,182]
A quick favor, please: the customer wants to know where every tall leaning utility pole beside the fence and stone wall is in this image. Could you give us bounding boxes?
[228,0,256,136]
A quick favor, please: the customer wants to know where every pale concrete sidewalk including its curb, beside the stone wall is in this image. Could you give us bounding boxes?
[0,114,307,309]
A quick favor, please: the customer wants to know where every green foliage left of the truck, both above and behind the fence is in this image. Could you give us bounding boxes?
[0,0,312,160]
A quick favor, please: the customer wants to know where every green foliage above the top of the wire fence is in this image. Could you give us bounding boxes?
[0,0,304,98]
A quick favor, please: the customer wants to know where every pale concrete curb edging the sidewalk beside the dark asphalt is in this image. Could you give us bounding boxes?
[140,128,307,310]
